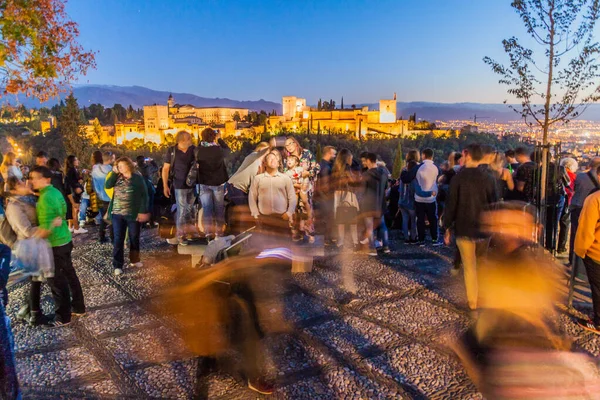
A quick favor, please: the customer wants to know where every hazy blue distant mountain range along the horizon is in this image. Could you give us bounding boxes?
[7,85,600,122]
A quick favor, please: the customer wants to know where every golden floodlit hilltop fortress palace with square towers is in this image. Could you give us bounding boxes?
[85,94,424,144]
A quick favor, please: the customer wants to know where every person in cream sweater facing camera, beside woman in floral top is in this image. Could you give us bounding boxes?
[248,150,297,241]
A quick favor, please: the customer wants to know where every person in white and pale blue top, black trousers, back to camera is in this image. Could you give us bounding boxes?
[415,149,442,246]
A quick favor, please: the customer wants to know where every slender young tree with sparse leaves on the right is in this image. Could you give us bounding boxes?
[483,0,600,221]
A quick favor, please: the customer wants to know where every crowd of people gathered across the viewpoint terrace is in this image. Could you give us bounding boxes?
[0,128,600,393]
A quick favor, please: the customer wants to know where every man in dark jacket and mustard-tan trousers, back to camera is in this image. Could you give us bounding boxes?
[444,144,497,310]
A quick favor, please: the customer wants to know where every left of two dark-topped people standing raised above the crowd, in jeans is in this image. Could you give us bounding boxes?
[162,131,196,246]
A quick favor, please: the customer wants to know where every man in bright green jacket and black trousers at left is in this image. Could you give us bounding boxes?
[29,166,85,326]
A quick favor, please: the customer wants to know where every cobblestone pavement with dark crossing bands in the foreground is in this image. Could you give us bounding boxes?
[8,231,600,399]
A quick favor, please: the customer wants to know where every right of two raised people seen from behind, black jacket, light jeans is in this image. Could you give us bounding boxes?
[196,128,231,239]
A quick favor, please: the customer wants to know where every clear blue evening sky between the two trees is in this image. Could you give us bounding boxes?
[67,0,548,104]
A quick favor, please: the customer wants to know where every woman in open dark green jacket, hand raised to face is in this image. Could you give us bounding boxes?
[105,157,150,275]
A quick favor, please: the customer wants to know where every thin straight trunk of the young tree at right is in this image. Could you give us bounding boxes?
[539,1,555,247]
